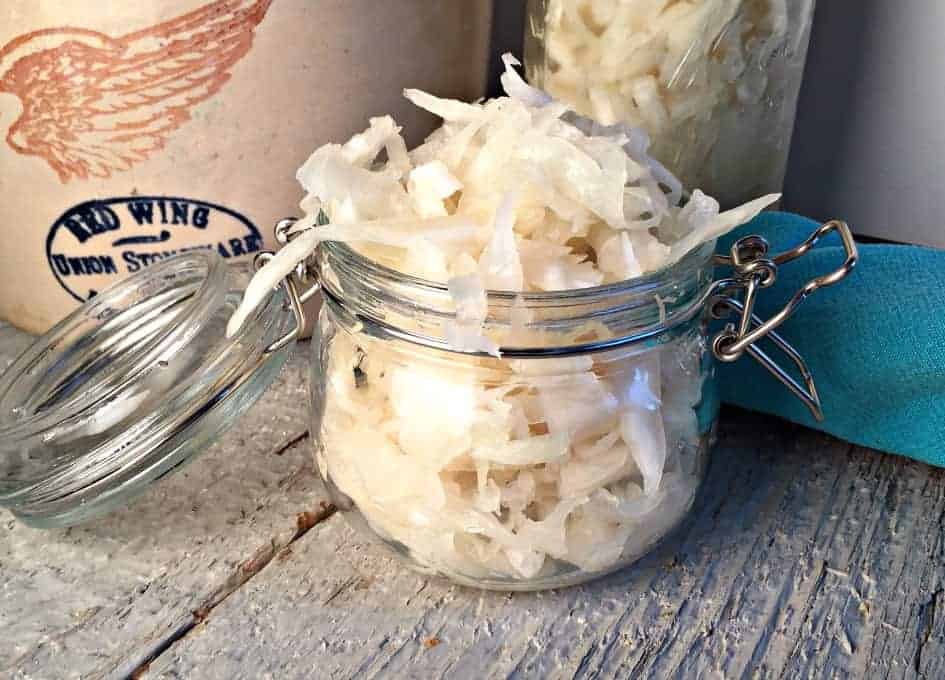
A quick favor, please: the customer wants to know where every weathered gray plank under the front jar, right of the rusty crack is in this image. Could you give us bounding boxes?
[151,412,945,679]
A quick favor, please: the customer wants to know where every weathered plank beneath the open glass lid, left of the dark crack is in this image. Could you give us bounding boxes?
[0,324,332,678]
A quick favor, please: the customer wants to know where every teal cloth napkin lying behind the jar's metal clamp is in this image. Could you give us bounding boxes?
[717,212,945,467]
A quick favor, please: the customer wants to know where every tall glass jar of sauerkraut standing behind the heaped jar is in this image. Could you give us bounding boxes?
[525,0,814,207]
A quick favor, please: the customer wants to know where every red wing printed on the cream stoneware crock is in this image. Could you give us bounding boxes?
[0,0,272,183]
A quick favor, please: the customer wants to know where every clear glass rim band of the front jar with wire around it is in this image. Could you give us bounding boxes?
[314,242,715,357]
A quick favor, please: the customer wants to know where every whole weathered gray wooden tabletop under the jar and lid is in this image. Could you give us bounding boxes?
[0,325,945,680]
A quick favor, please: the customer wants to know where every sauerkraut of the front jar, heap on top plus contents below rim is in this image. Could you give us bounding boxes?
[230,57,777,581]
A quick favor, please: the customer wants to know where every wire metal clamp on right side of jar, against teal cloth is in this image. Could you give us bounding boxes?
[709,220,859,421]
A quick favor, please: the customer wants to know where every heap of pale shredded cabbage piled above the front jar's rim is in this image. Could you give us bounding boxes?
[228,55,780,338]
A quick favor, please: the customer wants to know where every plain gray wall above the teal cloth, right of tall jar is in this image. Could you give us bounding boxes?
[785,0,945,248]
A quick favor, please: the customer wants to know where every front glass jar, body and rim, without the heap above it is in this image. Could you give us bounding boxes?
[311,236,717,590]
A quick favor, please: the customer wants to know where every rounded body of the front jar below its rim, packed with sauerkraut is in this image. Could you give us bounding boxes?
[311,286,718,590]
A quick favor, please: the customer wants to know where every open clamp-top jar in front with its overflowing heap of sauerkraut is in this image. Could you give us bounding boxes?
[221,55,856,590]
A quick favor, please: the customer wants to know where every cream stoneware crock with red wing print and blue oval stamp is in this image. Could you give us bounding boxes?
[0,0,491,332]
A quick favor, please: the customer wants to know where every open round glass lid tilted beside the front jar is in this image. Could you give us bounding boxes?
[0,251,296,527]
